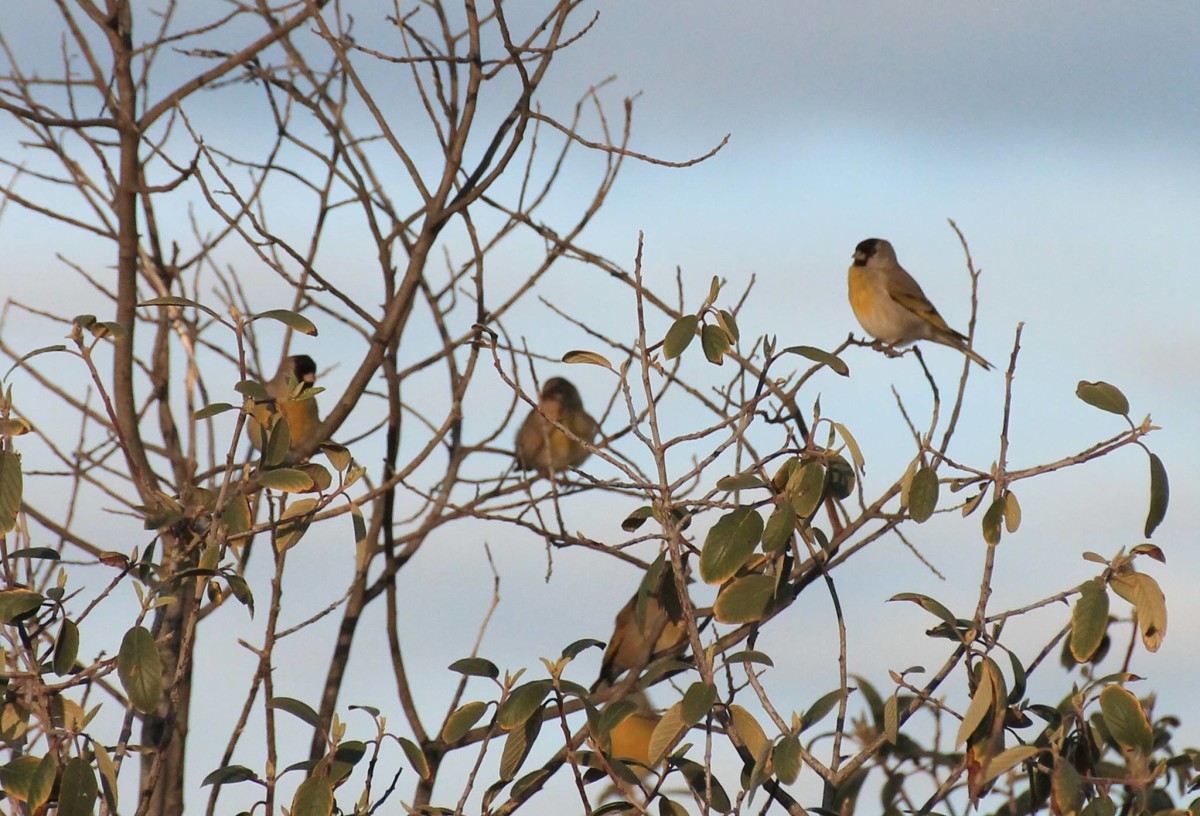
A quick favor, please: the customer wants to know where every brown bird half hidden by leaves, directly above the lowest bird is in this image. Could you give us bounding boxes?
[592,569,688,691]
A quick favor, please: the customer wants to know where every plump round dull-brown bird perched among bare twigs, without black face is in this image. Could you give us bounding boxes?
[514,377,599,476]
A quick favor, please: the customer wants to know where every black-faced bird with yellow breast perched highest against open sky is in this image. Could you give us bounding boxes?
[850,238,991,370]
